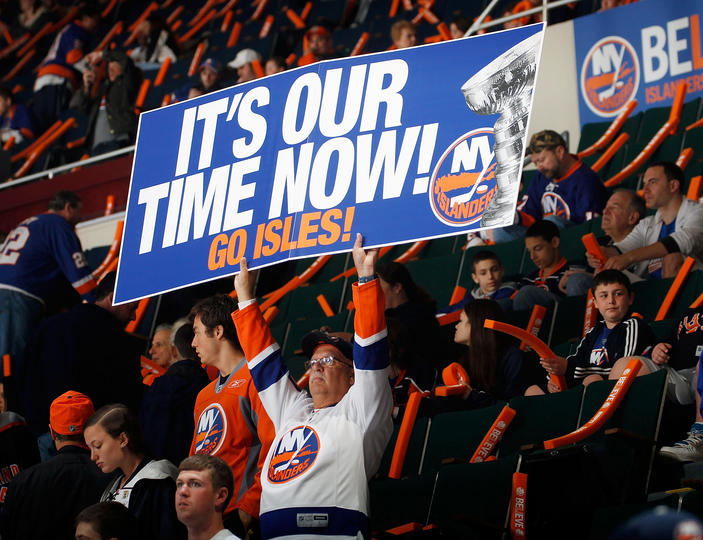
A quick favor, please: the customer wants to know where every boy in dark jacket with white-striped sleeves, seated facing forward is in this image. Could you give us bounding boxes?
[526,270,654,395]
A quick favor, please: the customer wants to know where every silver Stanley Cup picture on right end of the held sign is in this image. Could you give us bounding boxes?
[461,32,542,227]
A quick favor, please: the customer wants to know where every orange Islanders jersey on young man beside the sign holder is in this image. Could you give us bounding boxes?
[190,362,274,518]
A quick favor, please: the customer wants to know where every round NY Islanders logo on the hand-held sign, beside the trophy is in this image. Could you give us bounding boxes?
[429,128,497,227]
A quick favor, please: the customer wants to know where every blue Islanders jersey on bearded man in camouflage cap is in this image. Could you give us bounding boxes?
[518,157,608,223]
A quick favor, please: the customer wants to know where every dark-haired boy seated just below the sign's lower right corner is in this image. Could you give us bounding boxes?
[439,250,517,313]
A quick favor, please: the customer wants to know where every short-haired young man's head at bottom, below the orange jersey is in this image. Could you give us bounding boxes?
[176,454,239,540]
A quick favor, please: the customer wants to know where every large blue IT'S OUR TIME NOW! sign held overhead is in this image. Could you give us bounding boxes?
[115,25,542,302]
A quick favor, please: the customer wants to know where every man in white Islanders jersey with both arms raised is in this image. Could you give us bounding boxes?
[232,235,392,538]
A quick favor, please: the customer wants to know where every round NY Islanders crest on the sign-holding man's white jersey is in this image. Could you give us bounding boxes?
[268,426,320,484]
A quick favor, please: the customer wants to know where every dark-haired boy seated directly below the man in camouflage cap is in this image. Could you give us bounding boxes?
[513,220,592,310]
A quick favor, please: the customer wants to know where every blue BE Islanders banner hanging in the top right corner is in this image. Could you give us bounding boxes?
[574,0,703,125]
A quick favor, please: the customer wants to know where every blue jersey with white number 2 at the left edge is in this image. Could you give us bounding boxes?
[0,213,96,302]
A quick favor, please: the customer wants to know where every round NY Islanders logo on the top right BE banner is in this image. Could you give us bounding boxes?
[580,36,640,117]
